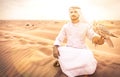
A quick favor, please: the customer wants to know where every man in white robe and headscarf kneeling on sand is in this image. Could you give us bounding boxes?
[53,6,104,77]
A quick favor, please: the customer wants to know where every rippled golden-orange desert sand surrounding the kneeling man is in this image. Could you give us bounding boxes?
[0,20,120,77]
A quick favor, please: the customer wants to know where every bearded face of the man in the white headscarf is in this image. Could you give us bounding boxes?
[69,8,80,20]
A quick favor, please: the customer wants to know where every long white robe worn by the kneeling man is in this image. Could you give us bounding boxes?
[54,23,97,77]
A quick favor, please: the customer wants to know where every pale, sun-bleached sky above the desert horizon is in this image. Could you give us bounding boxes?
[0,0,120,21]
